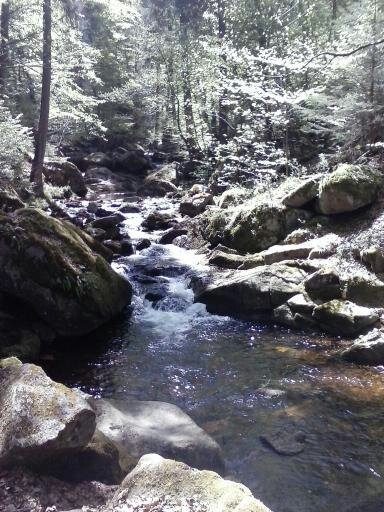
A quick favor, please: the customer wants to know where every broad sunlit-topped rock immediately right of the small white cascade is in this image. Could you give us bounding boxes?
[195,263,307,317]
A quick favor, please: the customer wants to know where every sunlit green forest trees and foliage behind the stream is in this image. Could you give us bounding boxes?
[0,0,384,188]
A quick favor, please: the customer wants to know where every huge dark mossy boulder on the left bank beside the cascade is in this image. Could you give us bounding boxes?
[0,208,132,337]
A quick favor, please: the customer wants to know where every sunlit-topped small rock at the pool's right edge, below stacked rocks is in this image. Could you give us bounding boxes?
[313,300,379,336]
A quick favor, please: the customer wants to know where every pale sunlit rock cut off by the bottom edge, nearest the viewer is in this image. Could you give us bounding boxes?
[103,454,271,512]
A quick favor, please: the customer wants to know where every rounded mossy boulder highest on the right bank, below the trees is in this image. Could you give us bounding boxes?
[318,164,383,215]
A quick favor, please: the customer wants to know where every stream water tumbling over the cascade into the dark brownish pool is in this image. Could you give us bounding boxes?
[46,188,384,512]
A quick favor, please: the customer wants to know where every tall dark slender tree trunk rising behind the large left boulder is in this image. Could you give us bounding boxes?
[31,0,52,196]
